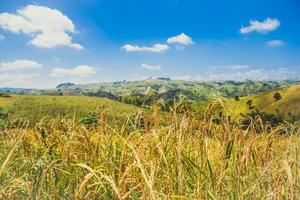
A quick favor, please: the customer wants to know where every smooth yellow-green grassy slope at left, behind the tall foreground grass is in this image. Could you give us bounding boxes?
[7,96,140,123]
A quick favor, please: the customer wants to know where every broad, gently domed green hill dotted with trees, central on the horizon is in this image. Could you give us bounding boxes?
[57,79,290,97]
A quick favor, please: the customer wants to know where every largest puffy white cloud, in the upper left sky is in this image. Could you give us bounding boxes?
[0,5,84,49]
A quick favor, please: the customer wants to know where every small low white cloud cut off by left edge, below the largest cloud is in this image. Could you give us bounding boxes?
[0,60,42,71]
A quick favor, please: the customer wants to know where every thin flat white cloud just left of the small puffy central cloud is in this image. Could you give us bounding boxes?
[122,44,170,53]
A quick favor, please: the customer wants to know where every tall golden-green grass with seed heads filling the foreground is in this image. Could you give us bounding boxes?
[0,100,300,200]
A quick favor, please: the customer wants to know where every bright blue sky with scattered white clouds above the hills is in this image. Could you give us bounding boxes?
[0,0,300,88]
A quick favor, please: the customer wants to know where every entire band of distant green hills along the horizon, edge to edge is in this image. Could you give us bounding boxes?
[0,78,297,102]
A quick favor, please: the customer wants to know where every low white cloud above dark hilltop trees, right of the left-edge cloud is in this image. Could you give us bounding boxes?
[51,65,96,77]
